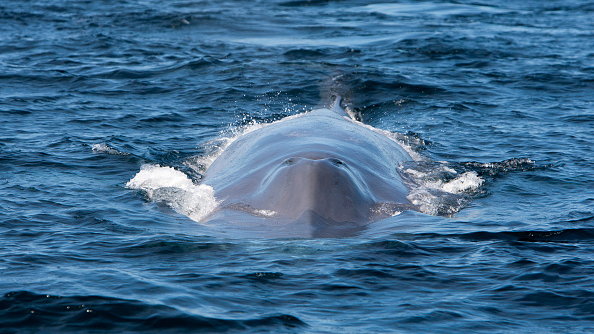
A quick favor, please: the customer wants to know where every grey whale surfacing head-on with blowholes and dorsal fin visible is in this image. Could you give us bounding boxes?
[202,98,414,237]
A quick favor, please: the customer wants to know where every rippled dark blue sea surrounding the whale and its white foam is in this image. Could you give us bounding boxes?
[0,0,594,333]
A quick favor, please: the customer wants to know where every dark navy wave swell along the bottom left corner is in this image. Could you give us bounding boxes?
[0,291,306,333]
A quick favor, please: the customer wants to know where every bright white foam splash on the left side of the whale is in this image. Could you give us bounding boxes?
[126,165,218,221]
